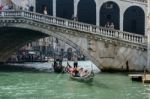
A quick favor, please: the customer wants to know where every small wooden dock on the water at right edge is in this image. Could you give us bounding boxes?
[129,74,150,83]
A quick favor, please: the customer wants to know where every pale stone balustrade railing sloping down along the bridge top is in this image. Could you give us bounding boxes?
[1,11,147,45]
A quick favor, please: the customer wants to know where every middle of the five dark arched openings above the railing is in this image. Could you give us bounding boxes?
[77,0,96,25]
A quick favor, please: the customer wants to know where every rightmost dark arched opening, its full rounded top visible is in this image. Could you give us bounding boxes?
[123,6,145,35]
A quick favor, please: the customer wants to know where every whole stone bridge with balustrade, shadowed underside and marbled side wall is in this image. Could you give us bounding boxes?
[0,11,147,70]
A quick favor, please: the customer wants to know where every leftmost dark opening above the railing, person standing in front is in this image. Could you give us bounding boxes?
[36,0,53,15]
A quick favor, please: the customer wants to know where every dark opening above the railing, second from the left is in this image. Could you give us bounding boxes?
[56,0,74,19]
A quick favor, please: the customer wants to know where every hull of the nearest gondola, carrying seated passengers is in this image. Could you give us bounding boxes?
[70,71,94,83]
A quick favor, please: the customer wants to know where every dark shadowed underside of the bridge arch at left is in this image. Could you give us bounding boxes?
[0,27,46,62]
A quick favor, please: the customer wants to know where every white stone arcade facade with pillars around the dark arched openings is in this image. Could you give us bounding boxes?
[32,0,147,35]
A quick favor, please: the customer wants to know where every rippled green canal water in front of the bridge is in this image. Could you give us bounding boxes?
[0,72,150,99]
